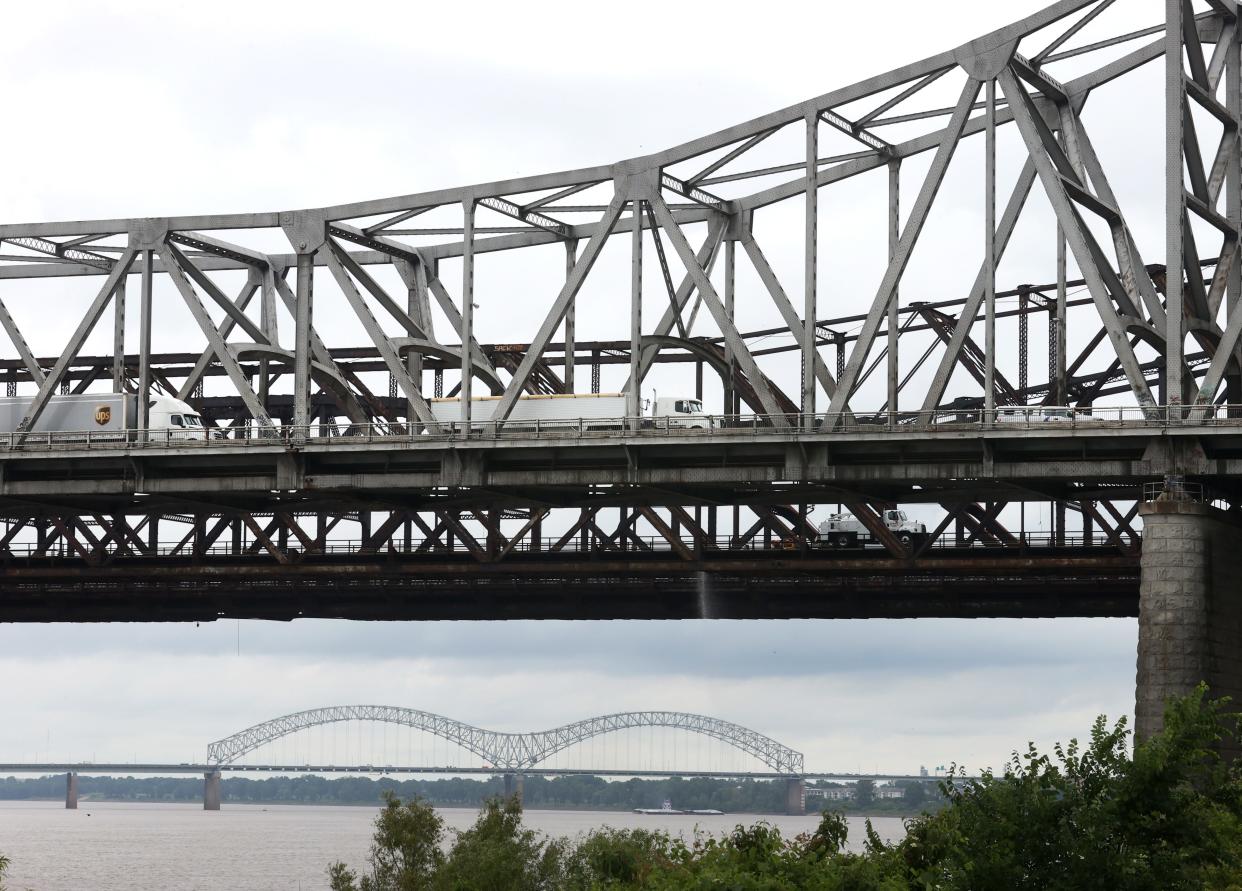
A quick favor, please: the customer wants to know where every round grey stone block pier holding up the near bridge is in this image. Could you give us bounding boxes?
[1134,496,1242,758]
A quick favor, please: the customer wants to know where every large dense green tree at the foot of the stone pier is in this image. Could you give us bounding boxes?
[894,686,1242,891]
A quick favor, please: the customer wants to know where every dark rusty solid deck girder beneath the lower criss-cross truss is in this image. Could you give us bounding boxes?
[0,542,1139,621]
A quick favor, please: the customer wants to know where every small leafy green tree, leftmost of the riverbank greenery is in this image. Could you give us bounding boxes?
[328,792,445,891]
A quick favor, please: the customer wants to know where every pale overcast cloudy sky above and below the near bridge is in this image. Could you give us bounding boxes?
[0,0,1161,772]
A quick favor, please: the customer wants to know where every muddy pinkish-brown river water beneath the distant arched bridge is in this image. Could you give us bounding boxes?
[0,802,904,891]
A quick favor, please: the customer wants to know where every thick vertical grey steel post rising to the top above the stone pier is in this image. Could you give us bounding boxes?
[1165,0,1186,412]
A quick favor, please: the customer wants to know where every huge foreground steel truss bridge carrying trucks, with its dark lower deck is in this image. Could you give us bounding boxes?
[0,0,1242,620]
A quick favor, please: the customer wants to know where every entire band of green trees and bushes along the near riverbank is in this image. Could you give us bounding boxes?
[329,687,1242,891]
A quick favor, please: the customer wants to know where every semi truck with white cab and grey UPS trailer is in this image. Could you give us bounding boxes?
[0,393,209,442]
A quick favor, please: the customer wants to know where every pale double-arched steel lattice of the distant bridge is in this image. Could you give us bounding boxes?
[207,706,804,777]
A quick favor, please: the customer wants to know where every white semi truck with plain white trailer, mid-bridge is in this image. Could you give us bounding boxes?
[431,393,712,430]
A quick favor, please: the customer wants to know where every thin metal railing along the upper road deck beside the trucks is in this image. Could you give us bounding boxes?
[0,405,1242,451]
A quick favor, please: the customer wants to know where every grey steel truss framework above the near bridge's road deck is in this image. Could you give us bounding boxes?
[0,0,1242,430]
